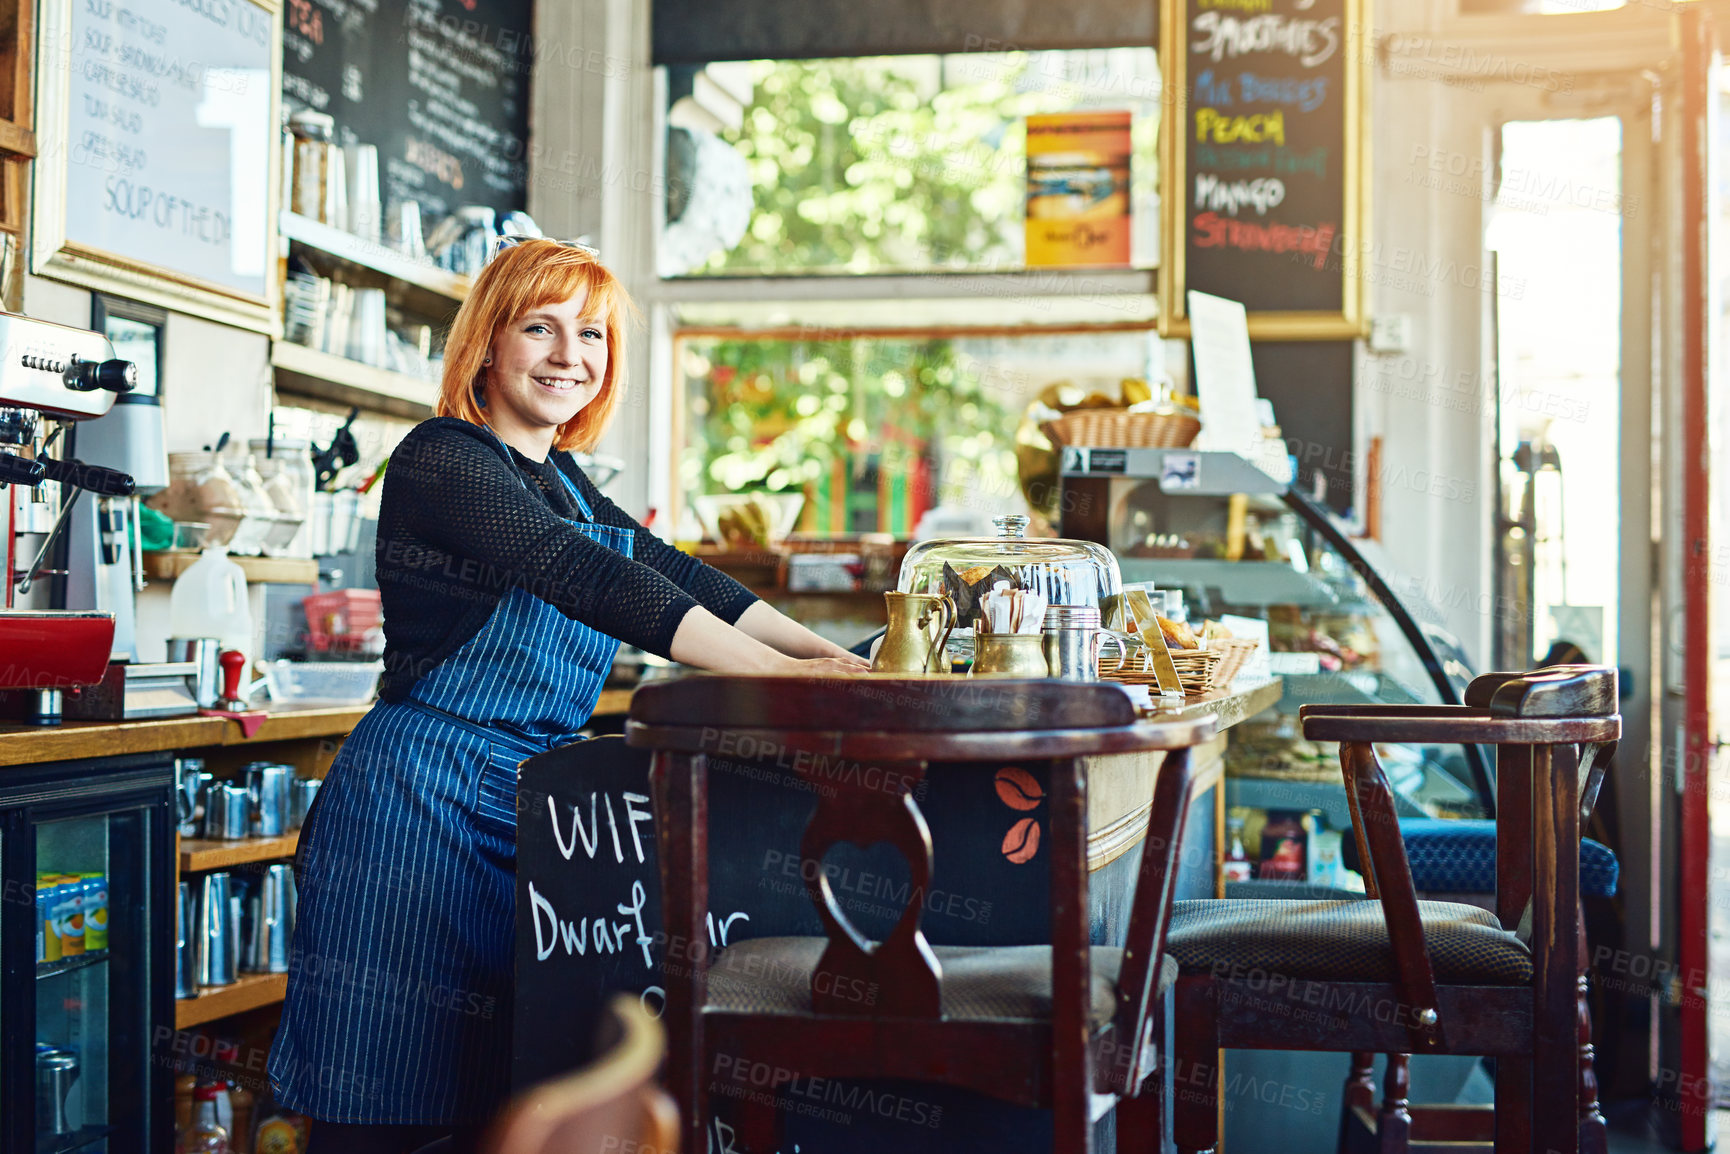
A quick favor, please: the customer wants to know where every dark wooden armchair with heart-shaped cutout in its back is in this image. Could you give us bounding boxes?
[626,676,1214,1152]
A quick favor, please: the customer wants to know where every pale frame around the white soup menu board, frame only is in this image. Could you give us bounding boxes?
[29,0,284,337]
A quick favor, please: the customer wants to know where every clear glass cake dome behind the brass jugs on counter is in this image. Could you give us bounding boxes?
[896,514,1123,657]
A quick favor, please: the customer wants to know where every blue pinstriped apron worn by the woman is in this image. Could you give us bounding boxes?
[270,460,633,1125]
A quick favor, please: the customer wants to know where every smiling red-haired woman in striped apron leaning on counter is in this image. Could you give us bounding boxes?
[270,240,868,1154]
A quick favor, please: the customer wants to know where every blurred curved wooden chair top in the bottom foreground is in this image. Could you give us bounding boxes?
[483,995,681,1154]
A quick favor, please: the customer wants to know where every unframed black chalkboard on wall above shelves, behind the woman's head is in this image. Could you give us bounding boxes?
[282,0,533,225]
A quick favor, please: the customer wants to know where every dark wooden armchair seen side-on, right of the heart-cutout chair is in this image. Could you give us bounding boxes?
[1166,666,1621,1154]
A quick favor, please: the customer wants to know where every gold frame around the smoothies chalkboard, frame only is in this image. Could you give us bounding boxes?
[1159,0,1374,341]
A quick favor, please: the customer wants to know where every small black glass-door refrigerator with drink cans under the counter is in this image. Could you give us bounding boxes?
[0,754,176,1154]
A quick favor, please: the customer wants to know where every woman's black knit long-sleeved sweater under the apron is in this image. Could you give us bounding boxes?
[377,417,756,701]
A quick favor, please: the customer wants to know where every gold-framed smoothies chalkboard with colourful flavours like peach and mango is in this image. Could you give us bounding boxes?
[1161,0,1365,337]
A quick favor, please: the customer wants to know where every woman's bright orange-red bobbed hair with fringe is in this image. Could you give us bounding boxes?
[433,240,635,450]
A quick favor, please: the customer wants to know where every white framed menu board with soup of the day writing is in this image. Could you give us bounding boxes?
[31,0,282,336]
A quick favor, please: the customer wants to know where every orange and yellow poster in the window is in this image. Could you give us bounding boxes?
[1028,112,1130,268]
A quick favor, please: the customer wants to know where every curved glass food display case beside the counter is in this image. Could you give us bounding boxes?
[1059,448,1495,884]
